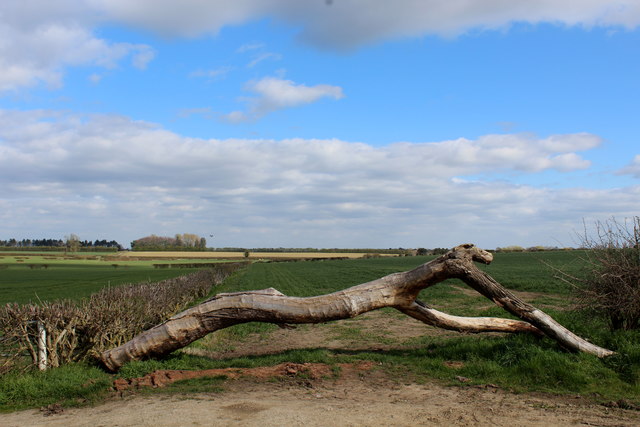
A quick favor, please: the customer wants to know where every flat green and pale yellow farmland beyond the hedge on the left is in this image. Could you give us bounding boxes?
[0,251,400,304]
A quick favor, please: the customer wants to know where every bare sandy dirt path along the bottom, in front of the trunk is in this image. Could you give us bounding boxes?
[0,377,640,427]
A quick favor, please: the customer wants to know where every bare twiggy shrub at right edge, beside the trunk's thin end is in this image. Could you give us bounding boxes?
[565,216,640,330]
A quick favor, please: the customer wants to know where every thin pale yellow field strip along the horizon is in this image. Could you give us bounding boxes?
[114,251,397,259]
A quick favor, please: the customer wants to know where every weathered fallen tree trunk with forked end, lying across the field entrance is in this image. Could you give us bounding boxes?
[101,244,613,371]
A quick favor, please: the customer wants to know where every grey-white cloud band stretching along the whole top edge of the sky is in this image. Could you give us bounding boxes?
[0,0,640,91]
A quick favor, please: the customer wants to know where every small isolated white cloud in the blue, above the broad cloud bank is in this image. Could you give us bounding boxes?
[223,77,344,123]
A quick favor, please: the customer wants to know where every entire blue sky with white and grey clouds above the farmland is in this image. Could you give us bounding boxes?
[0,0,640,249]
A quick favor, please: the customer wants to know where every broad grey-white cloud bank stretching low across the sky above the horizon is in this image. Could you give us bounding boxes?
[0,111,640,247]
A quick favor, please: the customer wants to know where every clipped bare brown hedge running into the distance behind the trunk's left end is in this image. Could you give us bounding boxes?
[0,263,246,373]
